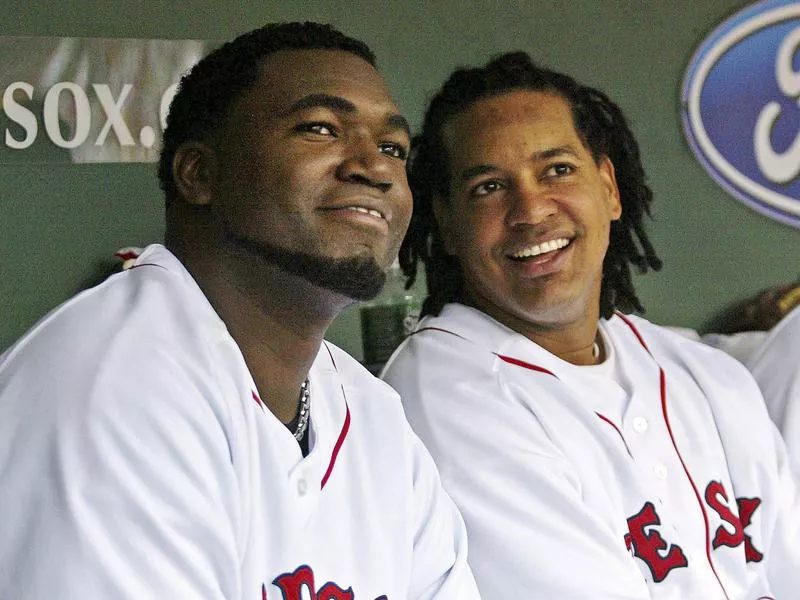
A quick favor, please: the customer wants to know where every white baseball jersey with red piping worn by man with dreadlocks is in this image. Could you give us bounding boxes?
[384,304,800,600]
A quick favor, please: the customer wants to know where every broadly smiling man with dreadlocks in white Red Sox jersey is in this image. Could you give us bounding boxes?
[384,52,800,600]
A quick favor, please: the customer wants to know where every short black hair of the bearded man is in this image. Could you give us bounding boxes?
[158,22,375,206]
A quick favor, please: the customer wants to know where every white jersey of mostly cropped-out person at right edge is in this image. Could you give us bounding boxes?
[745,306,800,481]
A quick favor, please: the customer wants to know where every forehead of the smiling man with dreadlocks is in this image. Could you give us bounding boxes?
[442,90,585,163]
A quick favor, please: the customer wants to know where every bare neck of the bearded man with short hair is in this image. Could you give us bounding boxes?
[169,230,349,423]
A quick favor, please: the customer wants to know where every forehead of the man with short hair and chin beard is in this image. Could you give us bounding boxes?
[241,50,397,113]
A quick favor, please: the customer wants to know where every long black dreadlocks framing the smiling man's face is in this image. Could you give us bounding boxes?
[400,52,661,318]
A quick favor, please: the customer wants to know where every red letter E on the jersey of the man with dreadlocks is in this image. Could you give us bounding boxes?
[625,502,689,583]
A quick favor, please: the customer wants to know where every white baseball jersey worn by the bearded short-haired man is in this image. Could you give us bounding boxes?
[0,246,477,600]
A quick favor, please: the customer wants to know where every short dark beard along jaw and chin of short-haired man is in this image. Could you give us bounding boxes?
[228,231,386,301]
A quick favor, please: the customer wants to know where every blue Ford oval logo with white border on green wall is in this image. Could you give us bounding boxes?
[682,0,800,228]
